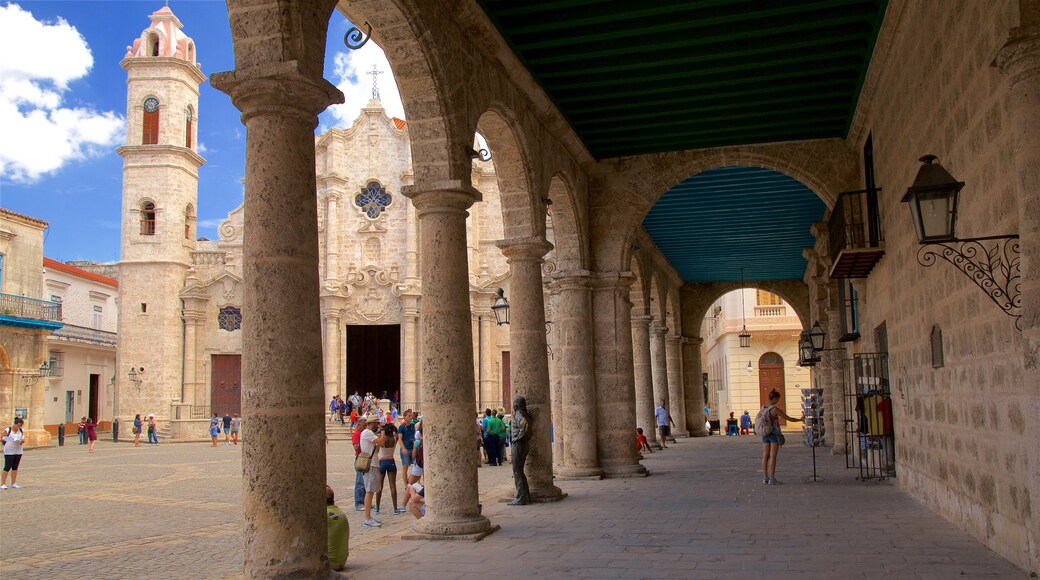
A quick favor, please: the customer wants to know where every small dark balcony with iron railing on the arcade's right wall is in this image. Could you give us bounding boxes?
[827,189,885,278]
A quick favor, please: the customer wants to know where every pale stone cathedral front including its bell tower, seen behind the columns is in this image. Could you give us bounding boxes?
[114,7,511,438]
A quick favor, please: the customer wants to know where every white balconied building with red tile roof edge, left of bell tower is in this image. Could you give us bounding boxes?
[43,258,119,434]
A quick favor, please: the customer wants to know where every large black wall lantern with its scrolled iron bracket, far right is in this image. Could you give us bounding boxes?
[903,155,1022,331]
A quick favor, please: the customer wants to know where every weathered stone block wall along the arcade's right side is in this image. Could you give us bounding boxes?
[851,0,1038,566]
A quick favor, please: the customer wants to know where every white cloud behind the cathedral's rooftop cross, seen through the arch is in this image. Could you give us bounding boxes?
[329,42,405,127]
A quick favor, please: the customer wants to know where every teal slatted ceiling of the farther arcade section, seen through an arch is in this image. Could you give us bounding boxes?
[643,166,826,282]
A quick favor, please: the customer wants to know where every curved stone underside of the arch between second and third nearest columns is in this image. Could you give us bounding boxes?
[476,104,545,240]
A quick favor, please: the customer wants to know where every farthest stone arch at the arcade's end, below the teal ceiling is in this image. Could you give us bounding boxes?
[680,280,812,337]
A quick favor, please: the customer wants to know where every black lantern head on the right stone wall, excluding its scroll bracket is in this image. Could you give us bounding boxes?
[903,155,964,243]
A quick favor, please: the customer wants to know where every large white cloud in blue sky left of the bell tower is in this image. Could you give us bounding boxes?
[0,4,124,183]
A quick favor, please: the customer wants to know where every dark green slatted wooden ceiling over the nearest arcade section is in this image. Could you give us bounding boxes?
[477,0,887,159]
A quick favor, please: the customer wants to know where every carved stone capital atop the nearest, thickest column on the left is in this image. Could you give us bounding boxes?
[209,60,344,124]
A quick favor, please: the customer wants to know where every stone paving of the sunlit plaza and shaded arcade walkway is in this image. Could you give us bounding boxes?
[0,436,1028,579]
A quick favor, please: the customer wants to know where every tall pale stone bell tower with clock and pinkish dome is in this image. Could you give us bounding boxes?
[112,6,206,433]
